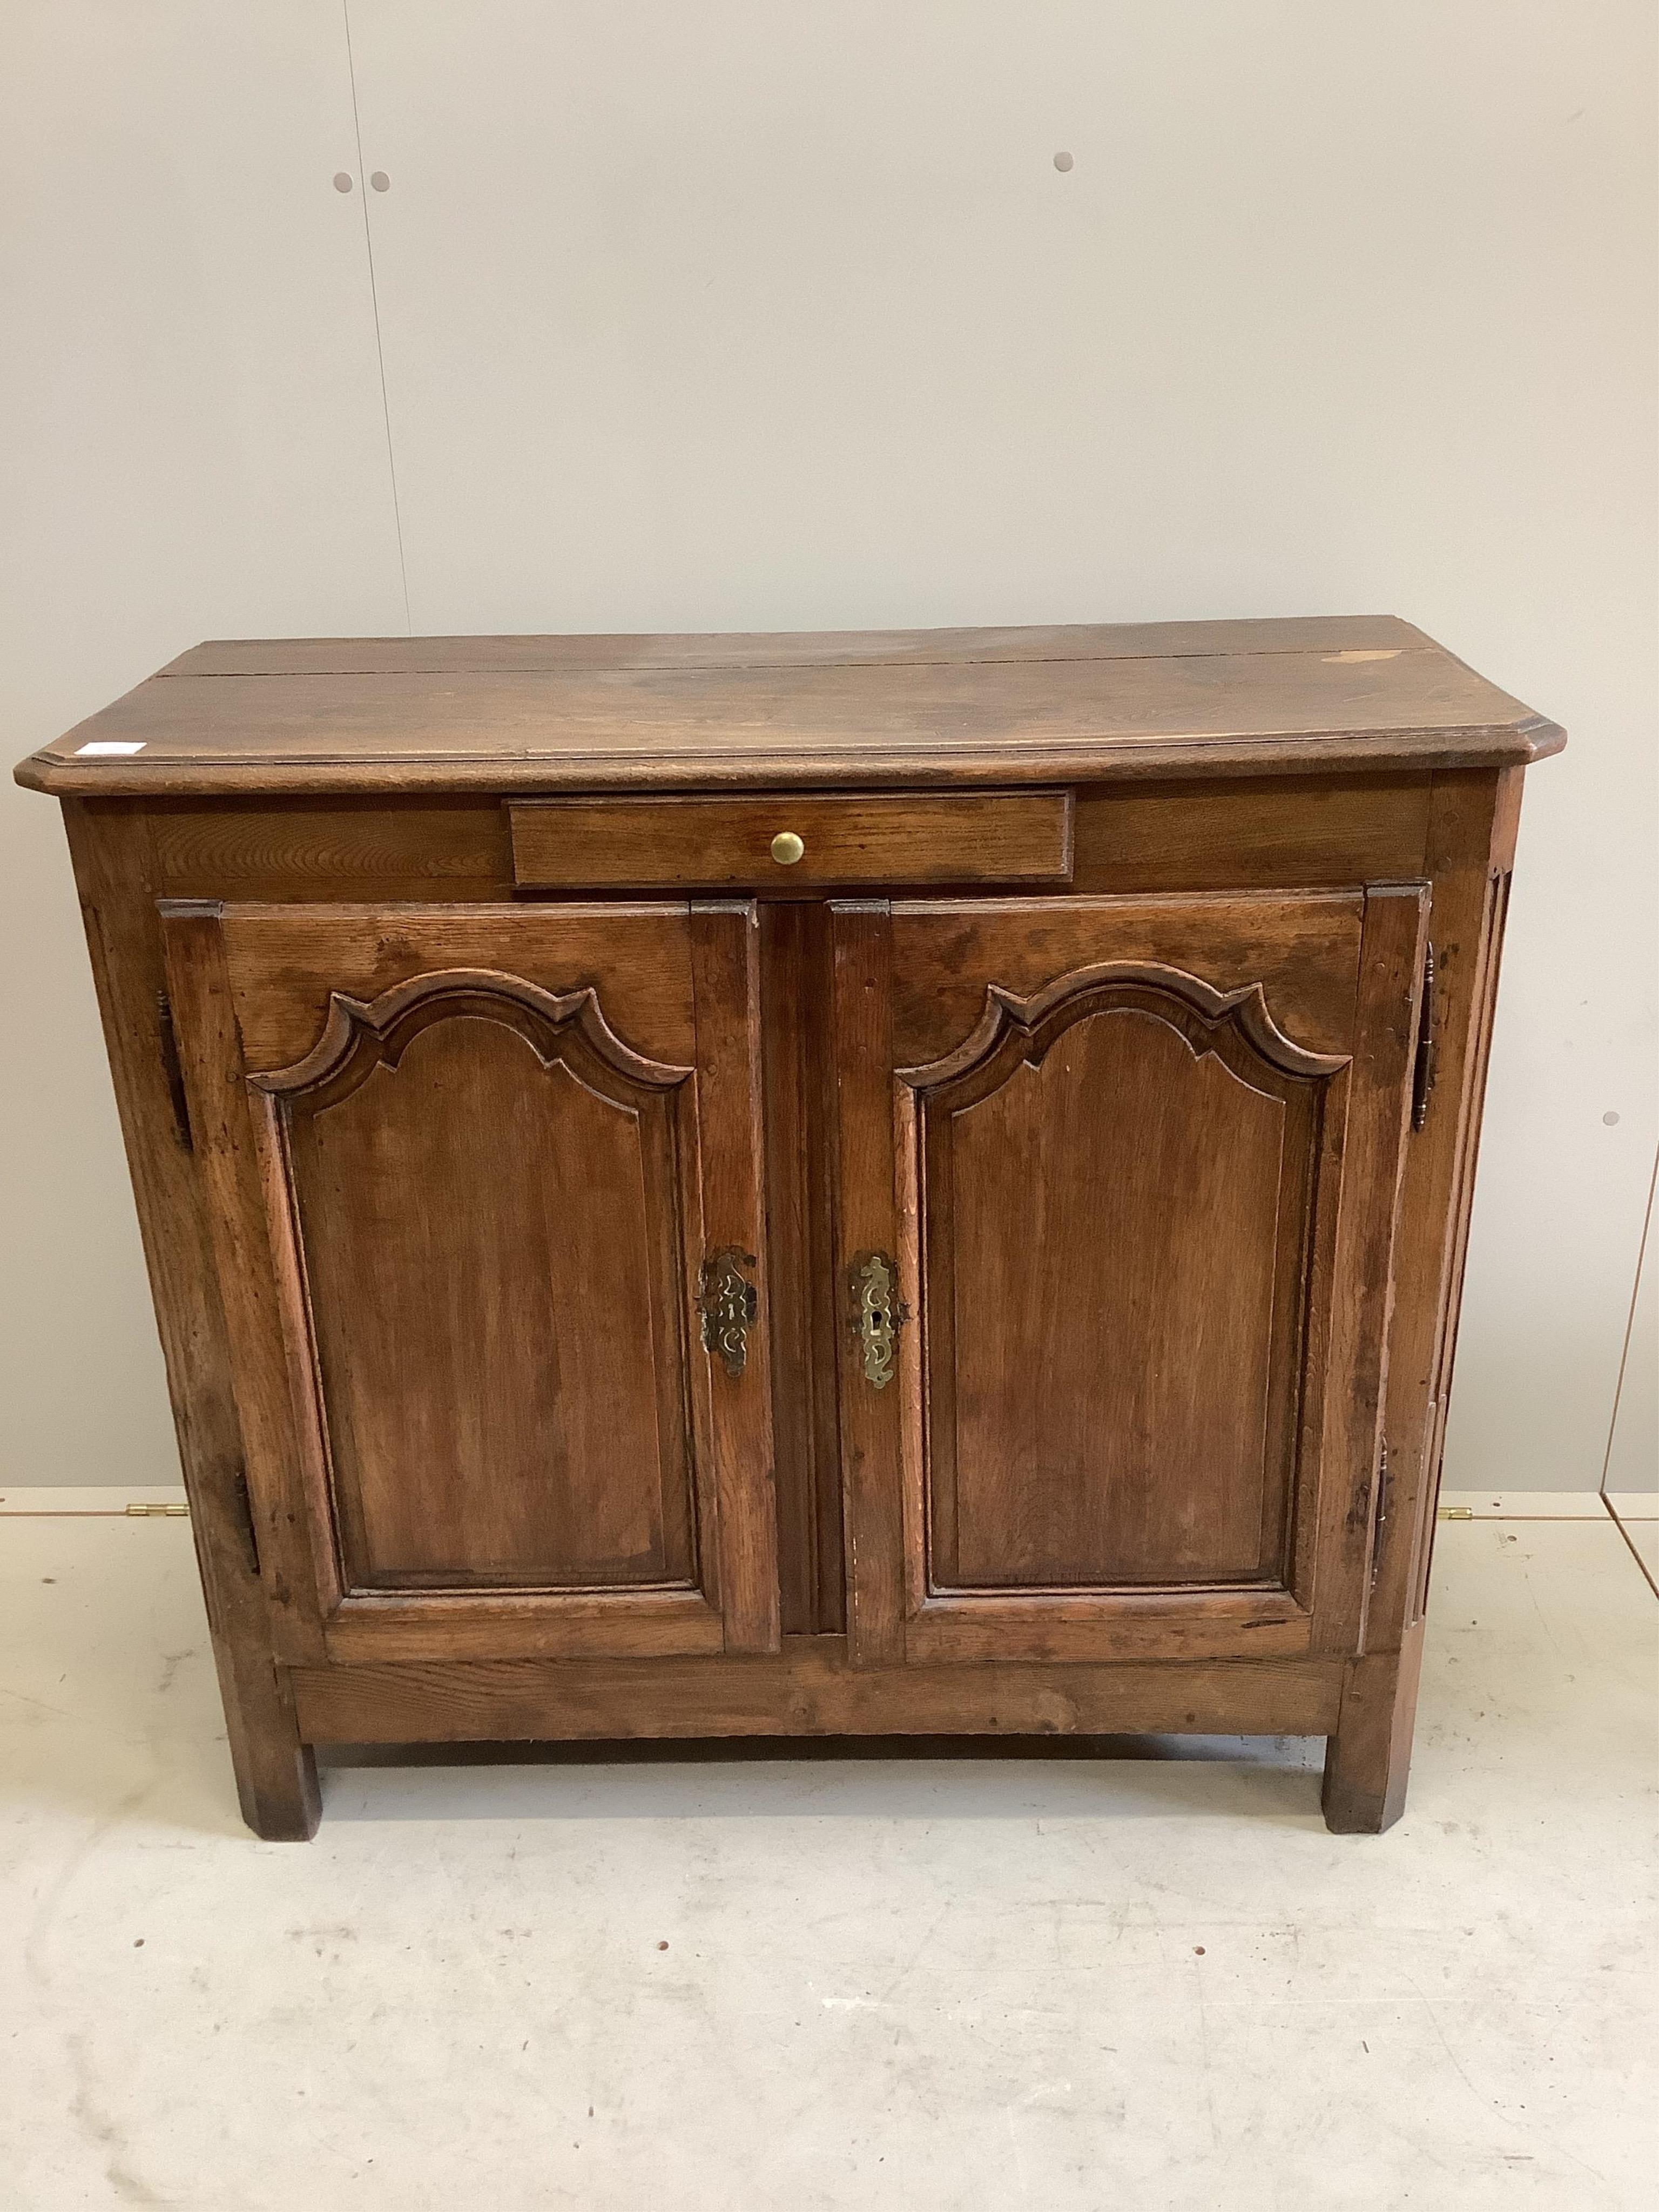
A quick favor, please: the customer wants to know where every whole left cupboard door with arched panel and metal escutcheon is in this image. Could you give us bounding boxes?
[161,905,779,1661]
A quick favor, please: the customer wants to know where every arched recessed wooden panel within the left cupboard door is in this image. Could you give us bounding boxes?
[252,969,697,1590]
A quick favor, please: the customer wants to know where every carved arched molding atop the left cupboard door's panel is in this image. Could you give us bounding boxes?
[248,969,692,1104]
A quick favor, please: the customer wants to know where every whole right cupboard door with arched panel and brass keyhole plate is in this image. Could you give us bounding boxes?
[834,885,1427,1665]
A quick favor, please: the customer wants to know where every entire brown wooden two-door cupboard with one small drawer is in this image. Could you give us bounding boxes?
[18,617,1562,1836]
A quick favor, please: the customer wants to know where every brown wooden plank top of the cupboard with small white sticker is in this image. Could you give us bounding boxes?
[16,615,1566,799]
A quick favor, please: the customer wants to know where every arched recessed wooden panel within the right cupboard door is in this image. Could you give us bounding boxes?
[902,962,1347,1593]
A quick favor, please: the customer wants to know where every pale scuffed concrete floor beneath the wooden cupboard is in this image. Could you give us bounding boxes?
[0,1518,1659,2212]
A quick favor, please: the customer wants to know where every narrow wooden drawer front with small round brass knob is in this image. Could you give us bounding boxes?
[507,792,1070,898]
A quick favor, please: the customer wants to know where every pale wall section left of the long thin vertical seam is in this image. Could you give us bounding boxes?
[0,0,405,1484]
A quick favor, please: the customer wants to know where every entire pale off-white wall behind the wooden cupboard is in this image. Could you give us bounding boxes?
[0,0,1659,1489]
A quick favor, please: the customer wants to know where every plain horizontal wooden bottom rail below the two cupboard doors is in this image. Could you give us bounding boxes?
[290,1637,1343,1743]
